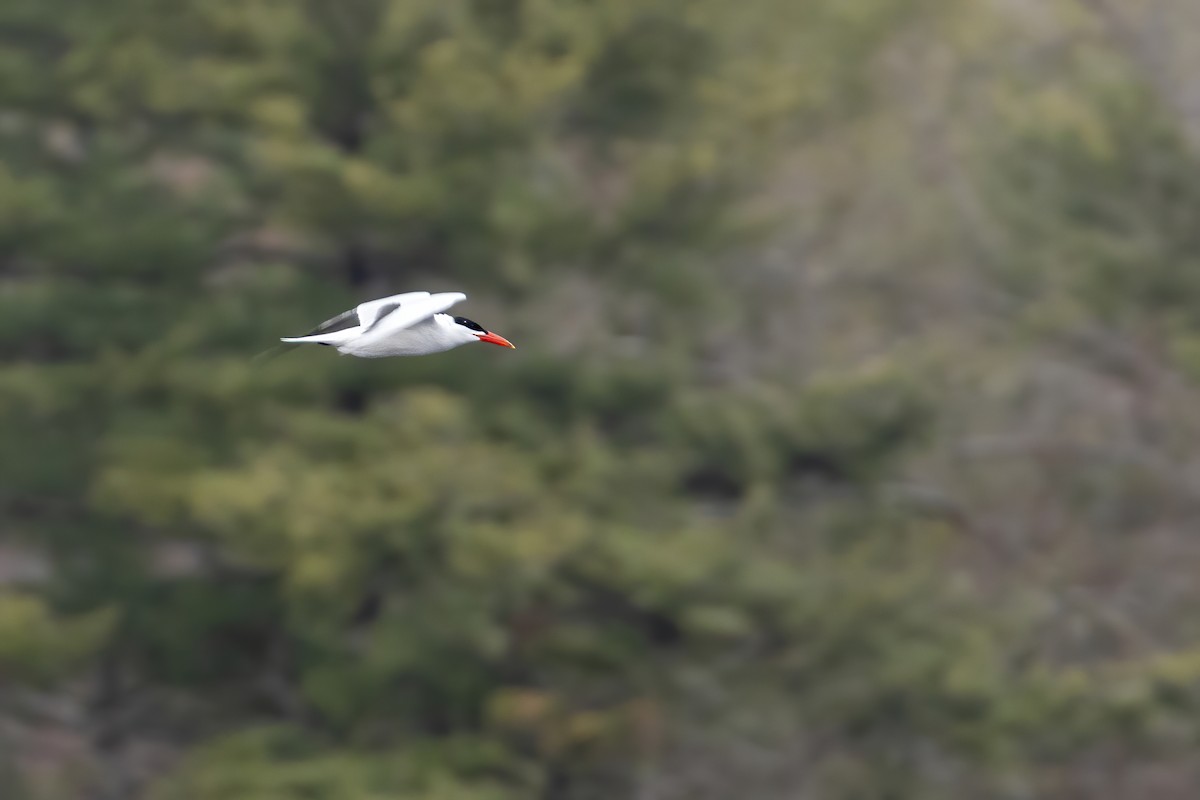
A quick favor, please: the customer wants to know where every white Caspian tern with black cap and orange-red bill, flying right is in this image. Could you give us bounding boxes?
[280,291,516,359]
